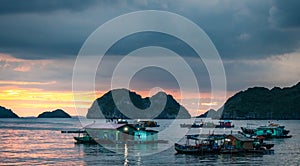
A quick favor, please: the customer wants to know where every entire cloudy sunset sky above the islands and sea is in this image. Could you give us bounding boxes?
[0,0,300,116]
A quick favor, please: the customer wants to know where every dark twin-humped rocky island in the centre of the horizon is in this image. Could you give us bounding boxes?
[86,89,191,119]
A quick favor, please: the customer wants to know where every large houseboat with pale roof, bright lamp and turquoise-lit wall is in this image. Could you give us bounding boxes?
[74,123,162,144]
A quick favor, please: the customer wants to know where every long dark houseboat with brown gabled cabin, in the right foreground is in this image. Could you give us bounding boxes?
[175,134,274,155]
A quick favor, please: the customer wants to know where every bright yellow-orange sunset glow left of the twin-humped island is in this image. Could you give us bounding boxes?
[0,87,94,117]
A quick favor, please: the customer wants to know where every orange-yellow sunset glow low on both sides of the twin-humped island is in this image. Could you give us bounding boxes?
[0,81,226,117]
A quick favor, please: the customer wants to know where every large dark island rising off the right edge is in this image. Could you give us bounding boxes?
[198,82,300,120]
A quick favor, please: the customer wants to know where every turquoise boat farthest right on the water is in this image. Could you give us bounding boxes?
[241,124,292,138]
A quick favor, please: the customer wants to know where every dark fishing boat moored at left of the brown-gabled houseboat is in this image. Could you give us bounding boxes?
[175,135,221,155]
